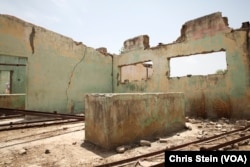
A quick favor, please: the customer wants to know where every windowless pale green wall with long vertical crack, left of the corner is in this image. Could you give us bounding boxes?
[0,15,112,113]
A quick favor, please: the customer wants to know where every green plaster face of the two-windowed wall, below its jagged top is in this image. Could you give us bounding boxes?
[114,31,250,117]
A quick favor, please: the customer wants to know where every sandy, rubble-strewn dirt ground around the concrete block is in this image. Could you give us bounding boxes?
[0,118,250,167]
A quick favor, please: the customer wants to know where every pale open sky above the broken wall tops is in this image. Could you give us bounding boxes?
[0,0,250,75]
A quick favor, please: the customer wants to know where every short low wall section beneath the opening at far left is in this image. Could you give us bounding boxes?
[0,94,25,109]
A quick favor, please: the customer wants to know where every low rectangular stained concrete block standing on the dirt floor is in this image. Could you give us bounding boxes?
[85,93,185,149]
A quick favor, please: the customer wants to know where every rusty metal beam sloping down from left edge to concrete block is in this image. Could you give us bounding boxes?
[0,108,85,120]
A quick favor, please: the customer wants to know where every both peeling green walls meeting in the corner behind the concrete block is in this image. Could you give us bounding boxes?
[0,14,250,117]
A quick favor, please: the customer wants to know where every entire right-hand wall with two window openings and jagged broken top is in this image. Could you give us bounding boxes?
[113,13,250,118]
